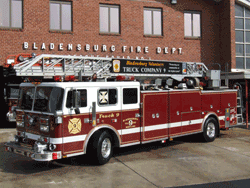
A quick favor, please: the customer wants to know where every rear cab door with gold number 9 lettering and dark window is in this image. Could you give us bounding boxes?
[121,86,141,144]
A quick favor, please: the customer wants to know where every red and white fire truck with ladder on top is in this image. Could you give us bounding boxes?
[5,54,237,164]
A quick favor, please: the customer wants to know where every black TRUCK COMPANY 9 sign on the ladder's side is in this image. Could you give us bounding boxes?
[110,59,187,74]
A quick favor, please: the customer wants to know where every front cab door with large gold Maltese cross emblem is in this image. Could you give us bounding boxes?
[62,88,91,155]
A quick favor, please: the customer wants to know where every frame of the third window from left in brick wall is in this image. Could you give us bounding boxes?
[99,4,121,35]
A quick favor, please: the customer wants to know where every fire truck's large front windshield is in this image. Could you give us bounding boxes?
[34,87,64,113]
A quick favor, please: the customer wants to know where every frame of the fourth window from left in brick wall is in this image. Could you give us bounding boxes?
[143,7,163,37]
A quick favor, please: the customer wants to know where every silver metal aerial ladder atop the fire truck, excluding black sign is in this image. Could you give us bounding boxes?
[5,53,208,85]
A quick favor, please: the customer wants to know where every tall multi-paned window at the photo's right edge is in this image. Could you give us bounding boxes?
[235,4,250,69]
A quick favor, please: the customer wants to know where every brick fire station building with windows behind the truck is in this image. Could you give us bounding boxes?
[0,0,250,126]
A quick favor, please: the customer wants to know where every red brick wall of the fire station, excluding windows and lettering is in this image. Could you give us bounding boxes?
[0,0,235,70]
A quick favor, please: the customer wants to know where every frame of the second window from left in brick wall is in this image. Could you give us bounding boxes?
[49,0,73,32]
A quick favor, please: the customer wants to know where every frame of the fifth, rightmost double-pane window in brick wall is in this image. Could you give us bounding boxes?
[183,11,202,39]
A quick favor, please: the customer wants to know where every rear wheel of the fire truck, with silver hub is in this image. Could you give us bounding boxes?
[202,117,218,142]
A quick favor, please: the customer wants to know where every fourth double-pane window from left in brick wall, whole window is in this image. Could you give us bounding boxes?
[144,8,162,36]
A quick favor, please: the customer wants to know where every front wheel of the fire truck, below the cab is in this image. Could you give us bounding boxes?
[92,131,113,165]
